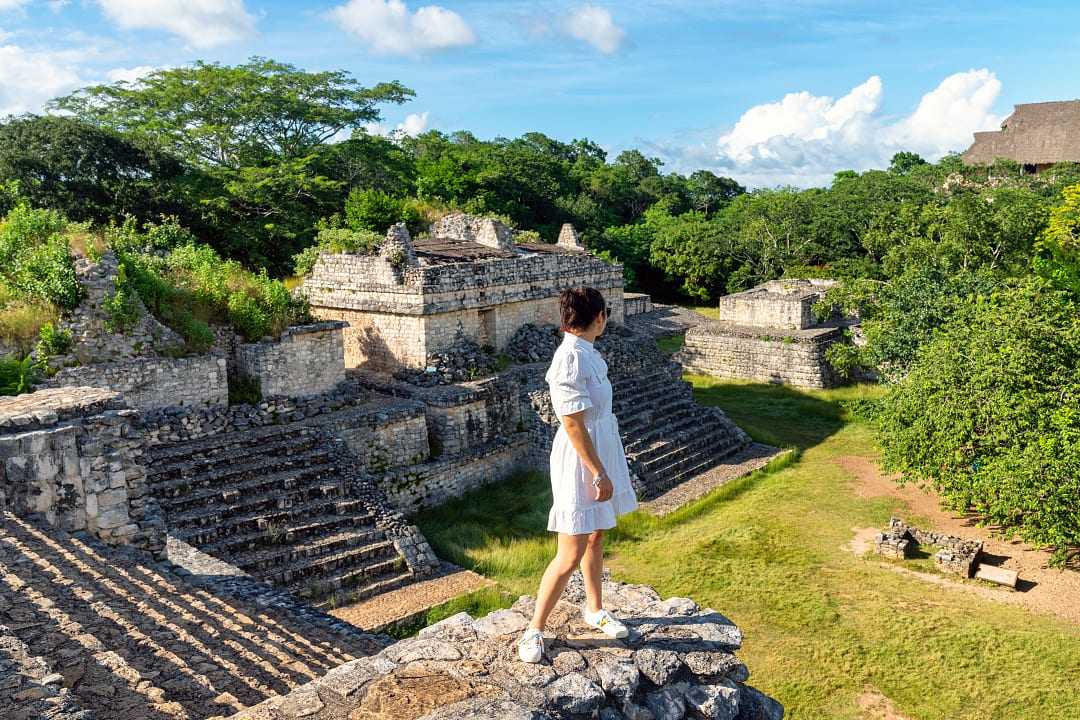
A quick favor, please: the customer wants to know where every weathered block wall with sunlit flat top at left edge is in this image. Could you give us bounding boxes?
[0,388,164,553]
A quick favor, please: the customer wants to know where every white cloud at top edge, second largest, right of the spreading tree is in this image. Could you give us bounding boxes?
[328,0,476,55]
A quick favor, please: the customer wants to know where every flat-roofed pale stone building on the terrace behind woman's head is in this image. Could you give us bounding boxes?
[303,215,623,369]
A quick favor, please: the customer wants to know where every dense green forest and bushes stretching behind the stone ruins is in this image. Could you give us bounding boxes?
[0,57,1080,560]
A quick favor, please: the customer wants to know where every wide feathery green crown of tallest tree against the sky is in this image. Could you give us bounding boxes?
[51,57,415,169]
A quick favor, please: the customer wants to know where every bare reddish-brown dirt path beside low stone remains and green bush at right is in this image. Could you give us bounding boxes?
[837,456,1080,626]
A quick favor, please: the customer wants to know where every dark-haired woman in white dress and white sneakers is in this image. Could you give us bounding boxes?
[517,287,637,663]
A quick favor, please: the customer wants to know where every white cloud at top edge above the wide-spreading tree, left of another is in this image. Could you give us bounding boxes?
[96,0,255,47]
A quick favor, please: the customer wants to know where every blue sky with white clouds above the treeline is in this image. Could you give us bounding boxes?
[0,0,1080,186]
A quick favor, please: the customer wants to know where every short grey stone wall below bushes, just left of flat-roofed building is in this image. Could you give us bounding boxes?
[230,322,346,397]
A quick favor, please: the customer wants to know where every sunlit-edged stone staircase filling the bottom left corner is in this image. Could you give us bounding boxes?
[0,513,388,720]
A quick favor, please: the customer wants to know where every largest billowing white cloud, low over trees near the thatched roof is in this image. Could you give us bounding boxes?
[657,68,1001,187]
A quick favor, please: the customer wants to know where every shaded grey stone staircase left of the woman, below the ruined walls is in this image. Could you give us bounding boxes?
[148,424,413,607]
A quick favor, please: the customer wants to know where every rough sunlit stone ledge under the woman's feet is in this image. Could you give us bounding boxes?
[231,579,784,720]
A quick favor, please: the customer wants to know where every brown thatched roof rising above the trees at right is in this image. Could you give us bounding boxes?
[963,100,1080,165]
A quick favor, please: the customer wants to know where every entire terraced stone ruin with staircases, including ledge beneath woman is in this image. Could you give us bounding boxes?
[0,216,783,720]
